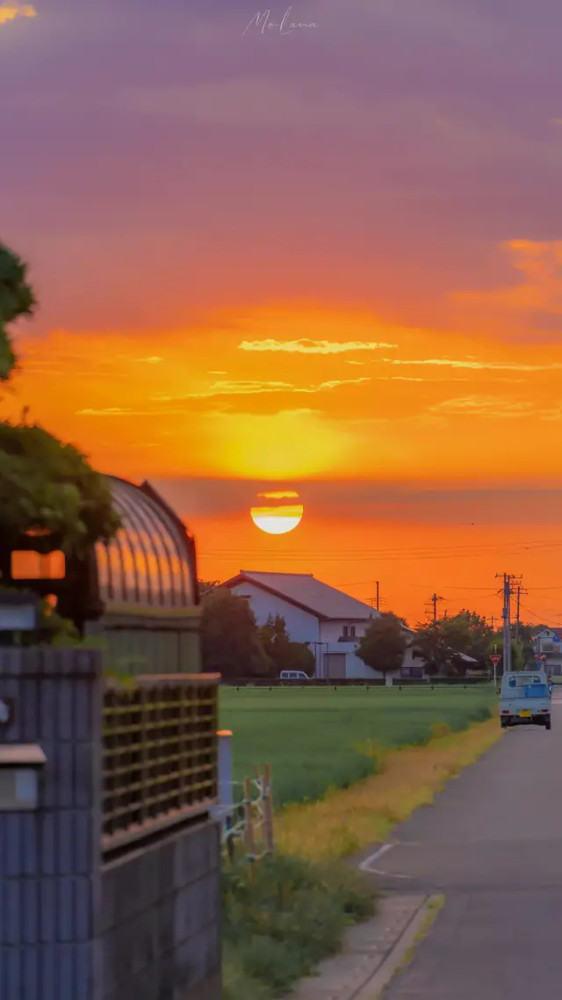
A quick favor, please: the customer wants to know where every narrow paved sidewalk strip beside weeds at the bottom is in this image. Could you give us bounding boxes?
[293,895,429,1000]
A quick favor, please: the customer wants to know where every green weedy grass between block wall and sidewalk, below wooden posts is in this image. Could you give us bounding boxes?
[223,854,375,1000]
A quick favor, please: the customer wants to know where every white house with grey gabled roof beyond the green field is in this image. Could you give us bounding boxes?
[223,570,423,679]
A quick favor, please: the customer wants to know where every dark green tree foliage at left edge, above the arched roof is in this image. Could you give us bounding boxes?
[0,243,119,553]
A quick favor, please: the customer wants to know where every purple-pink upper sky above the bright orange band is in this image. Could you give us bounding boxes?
[0,0,562,332]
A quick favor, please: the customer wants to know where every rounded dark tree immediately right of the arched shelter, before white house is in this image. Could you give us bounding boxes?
[201,587,271,677]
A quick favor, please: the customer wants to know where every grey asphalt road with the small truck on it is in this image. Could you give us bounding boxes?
[360,694,562,1000]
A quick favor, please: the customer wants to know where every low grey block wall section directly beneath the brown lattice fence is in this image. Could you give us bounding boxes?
[99,820,221,1000]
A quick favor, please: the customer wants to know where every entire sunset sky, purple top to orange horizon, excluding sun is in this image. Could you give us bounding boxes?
[0,0,562,625]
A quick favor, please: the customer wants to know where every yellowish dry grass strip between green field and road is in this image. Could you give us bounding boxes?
[275,719,501,861]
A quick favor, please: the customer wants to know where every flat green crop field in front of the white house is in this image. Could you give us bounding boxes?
[220,686,497,806]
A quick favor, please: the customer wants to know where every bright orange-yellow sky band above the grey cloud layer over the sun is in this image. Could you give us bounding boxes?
[8,241,562,481]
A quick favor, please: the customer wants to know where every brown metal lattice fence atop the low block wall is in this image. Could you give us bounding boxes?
[102,674,219,853]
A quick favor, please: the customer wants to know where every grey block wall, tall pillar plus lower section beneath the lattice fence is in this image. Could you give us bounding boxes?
[0,649,221,1000]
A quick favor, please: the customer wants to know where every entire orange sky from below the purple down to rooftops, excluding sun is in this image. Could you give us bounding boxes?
[4,242,562,624]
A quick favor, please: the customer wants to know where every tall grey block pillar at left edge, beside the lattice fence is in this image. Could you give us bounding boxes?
[0,648,102,1000]
